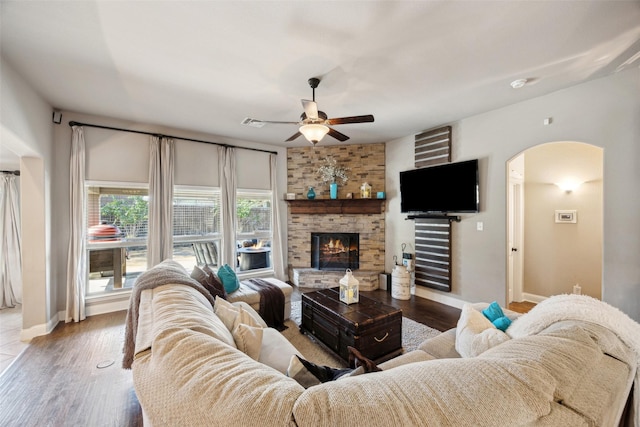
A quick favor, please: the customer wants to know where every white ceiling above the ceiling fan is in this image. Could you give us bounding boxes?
[1,0,640,167]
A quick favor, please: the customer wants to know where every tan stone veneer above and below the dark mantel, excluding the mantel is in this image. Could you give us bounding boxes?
[287,142,385,288]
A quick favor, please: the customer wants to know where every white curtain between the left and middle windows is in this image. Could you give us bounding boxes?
[147,136,175,268]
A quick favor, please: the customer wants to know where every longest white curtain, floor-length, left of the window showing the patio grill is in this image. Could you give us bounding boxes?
[65,126,87,322]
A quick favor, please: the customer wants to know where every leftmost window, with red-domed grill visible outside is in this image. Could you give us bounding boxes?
[86,184,149,295]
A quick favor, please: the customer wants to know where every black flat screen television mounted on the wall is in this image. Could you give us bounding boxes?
[400,159,480,214]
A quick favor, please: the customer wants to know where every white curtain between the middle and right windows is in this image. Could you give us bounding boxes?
[218,147,237,268]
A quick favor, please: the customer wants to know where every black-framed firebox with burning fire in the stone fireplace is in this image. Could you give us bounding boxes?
[311,233,360,270]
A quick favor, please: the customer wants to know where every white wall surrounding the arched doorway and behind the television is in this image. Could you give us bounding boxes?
[385,69,640,320]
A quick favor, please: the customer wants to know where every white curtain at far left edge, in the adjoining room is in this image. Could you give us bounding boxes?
[0,174,22,308]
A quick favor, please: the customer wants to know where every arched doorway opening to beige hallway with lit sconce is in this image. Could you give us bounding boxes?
[506,141,603,303]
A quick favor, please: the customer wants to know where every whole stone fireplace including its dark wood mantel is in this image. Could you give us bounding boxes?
[287,144,386,291]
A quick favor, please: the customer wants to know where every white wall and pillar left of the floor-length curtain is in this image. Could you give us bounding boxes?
[0,57,57,332]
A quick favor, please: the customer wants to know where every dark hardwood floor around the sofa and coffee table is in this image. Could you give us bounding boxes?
[0,287,460,427]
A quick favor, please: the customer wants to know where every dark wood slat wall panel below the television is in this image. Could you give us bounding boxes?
[415,218,451,292]
